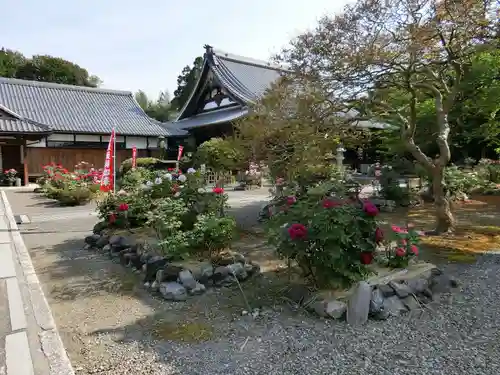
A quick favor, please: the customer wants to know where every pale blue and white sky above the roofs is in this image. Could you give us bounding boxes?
[0,0,349,99]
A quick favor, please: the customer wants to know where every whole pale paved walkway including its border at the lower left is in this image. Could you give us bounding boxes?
[0,191,74,375]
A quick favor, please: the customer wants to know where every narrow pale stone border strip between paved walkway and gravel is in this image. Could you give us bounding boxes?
[0,190,75,375]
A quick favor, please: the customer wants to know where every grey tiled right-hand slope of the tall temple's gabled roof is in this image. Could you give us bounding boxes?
[205,47,286,104]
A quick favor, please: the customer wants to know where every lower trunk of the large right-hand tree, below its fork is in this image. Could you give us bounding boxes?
[432,165,455,234]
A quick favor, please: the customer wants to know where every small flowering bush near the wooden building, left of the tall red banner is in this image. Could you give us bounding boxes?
[37,162,102,206]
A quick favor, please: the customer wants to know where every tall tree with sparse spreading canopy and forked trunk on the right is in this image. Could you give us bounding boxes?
[280,0,498,233]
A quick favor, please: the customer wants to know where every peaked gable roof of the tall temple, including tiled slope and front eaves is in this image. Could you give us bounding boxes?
[176,45,286,125]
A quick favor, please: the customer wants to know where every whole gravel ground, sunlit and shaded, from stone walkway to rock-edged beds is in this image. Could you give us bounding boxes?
[9,192,500,375]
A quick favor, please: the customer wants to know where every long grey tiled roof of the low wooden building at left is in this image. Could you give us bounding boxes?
[0,77,170,136]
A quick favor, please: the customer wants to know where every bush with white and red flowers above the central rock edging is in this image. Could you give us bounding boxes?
[98,168,236,258]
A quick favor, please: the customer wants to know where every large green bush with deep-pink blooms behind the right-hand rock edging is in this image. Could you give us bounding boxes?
[267,183,378,287]
